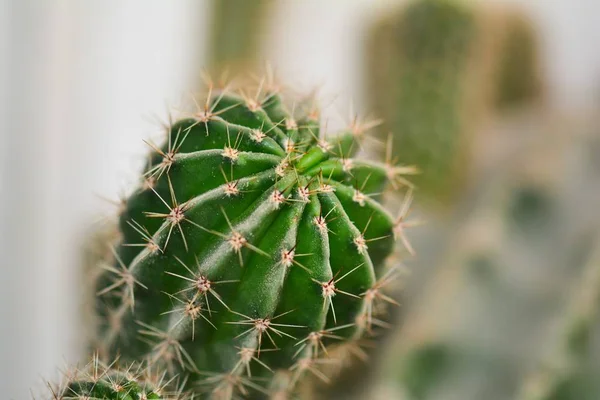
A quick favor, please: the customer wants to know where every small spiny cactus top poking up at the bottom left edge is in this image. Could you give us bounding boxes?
[43,355,184,400]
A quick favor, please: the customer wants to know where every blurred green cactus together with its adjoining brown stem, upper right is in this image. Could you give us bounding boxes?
[365,0,541,205]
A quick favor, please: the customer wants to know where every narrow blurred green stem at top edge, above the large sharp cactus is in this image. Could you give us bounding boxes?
[208,0,276,75]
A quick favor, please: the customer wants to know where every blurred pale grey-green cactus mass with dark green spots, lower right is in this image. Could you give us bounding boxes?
[370,111,600,400]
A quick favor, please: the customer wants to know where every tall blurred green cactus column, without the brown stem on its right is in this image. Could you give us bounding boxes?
[367,0,477,206]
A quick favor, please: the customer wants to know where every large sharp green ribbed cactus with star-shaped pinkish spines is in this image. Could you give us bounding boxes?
[97,76,413,398]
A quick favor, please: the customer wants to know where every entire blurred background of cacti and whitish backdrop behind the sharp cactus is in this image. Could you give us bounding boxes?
[0,0,600,400]
